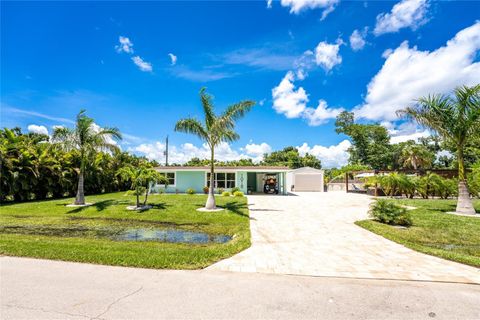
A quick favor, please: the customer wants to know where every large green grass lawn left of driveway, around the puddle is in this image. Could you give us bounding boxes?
[0,192,250,269]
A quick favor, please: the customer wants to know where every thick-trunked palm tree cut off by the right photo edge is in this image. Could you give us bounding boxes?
[399,84,480,214]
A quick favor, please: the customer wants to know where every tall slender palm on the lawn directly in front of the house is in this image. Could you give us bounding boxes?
[175,88,255,210]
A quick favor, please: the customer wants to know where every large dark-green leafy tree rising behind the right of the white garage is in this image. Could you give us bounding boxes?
[335,111,394,169]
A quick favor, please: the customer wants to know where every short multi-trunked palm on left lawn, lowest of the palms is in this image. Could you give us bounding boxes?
[117,163,167,208]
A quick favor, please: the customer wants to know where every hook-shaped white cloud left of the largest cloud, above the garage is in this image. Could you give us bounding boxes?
[272,71,343,126]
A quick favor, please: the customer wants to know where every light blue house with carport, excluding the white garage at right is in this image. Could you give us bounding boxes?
[152,166,291,194]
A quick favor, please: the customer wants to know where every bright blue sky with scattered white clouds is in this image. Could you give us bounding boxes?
[0,0,480,167]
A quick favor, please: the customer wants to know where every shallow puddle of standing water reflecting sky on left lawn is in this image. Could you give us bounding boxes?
[115,229,232,243]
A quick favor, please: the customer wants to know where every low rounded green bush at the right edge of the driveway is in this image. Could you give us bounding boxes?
[368,199,412,227]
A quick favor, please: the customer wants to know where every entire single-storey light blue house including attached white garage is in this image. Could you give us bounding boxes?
[152,166,323,194]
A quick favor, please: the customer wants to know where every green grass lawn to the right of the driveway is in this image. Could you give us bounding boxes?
[356,199,480,267]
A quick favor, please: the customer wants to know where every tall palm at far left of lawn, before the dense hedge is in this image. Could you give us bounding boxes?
[52,110,122,205]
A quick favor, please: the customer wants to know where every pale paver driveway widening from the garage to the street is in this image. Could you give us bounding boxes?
[209,192,480,283]
